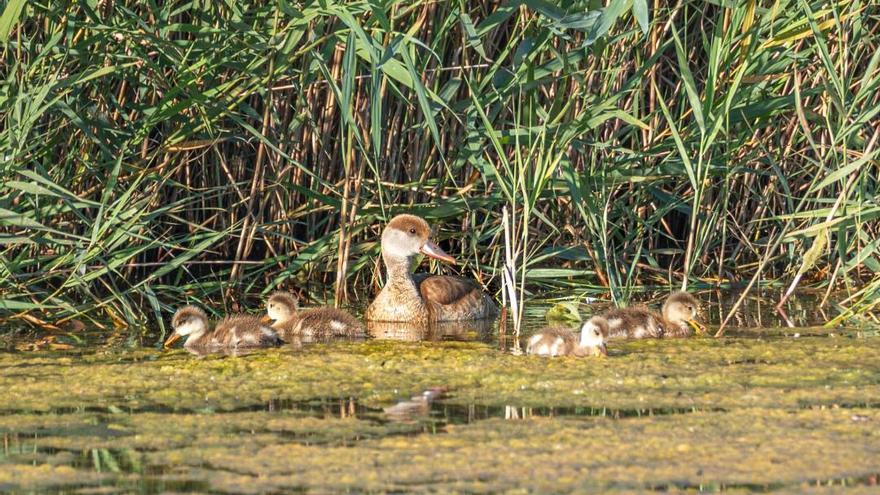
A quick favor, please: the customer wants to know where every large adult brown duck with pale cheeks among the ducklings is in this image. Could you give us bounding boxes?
[366,215,498,323]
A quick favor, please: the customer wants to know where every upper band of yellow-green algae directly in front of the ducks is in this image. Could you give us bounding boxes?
[0,337,880,412]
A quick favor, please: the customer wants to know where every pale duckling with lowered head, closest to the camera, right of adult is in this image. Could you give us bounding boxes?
[526,316,608,357]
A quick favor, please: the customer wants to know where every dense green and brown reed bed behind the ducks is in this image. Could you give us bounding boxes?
[0,0,880,334]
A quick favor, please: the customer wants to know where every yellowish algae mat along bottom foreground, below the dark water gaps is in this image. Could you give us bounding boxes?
[139,410,880,493]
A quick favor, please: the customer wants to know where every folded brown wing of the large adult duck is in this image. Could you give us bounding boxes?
[413,274,497,321]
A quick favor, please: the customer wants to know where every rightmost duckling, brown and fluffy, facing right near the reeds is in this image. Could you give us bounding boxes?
[602,291,703,339]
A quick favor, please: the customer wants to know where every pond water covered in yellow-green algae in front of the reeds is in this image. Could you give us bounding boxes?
[0,294,880,493]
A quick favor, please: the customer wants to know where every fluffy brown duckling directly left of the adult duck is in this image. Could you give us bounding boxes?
[266,292,364,340]
